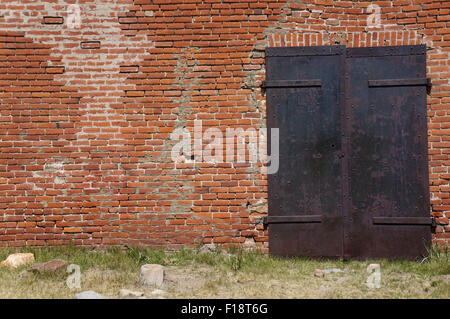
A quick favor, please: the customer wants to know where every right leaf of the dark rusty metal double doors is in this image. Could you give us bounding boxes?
[344,46,431,258]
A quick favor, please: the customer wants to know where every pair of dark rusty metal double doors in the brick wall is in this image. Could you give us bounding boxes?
[263,46,431,258]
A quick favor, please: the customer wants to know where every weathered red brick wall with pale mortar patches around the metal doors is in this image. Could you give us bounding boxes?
[0,0,450,248]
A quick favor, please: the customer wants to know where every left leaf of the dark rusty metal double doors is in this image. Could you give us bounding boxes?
[265,47,345,257]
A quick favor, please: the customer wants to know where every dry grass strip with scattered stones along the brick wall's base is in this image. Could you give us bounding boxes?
[0,247,450,299]
